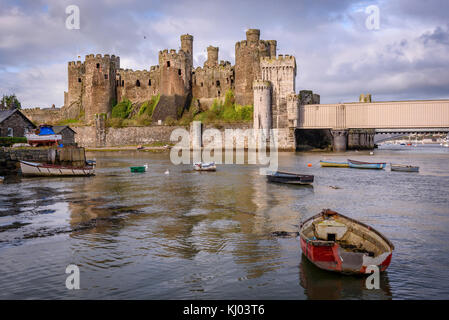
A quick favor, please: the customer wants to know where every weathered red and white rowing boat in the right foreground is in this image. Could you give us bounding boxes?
[300,209,394,274]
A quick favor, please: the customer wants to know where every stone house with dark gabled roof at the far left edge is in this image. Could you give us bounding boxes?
[0,109,36,137]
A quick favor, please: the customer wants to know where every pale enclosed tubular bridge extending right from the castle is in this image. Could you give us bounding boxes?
[296,100,449,151]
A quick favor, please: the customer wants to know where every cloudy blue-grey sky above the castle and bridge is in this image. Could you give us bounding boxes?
[0,0,449,108]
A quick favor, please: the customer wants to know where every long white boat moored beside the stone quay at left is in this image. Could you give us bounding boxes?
[20,160,95,177]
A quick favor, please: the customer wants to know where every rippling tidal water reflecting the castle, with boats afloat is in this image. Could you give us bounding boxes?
[0,145,449,299]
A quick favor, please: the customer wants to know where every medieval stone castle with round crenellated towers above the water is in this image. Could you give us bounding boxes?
[23,29,319,149]
